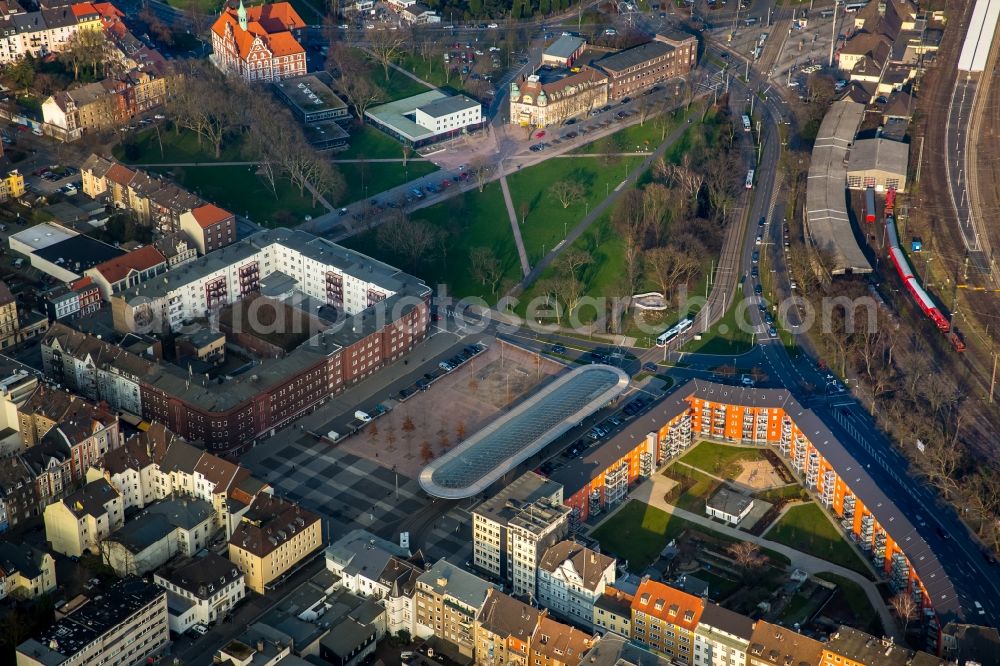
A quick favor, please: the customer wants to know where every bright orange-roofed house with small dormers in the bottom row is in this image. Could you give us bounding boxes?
[632,579,705,665]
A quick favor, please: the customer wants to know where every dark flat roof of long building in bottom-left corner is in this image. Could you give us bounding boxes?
[17,578,166,666]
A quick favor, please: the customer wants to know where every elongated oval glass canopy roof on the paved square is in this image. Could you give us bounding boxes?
[420,364,629,499]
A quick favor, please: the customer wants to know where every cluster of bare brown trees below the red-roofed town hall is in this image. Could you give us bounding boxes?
[168,61,345,205]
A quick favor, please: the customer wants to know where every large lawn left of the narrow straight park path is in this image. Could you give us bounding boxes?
[344,182,521,303]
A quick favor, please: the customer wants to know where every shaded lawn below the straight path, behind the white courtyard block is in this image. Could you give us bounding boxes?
[151,166,324,227]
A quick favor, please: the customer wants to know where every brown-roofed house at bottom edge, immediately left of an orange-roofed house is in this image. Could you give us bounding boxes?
[475,590,540,666]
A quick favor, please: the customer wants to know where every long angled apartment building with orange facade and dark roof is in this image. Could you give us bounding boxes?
[551,380,959,628]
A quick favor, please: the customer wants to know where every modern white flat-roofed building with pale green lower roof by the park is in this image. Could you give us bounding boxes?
[365,90,485,148]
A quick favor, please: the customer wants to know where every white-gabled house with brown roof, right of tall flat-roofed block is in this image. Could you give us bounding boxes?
[537,541,617,629]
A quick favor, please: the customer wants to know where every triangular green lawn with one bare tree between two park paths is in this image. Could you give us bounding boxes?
[507,152,640,264]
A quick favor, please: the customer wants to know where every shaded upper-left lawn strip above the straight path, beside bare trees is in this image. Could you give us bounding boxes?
[112,127,245,165]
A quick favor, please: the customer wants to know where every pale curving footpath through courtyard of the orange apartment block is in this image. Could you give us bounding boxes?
[624,477,903,644]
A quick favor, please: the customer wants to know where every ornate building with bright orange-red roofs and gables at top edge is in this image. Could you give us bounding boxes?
[212,0,306,81]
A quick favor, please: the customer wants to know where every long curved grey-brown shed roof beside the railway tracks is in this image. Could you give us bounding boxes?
[806,99,872,275]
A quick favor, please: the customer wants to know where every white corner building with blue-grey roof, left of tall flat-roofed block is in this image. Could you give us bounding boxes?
[326,530,424,636]
